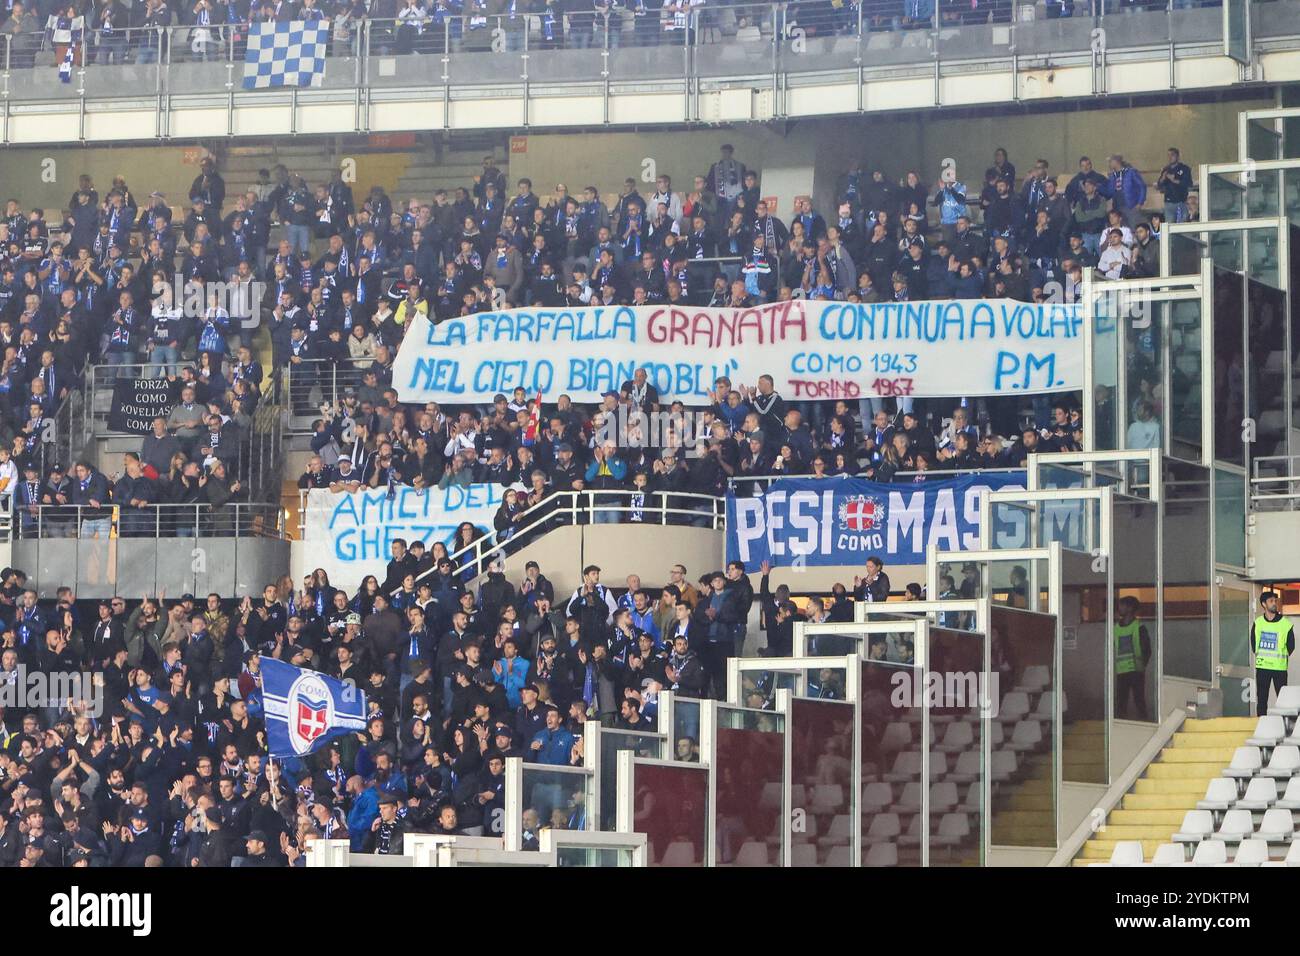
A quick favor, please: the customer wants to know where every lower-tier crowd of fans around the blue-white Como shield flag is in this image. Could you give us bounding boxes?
[0,541,919,866]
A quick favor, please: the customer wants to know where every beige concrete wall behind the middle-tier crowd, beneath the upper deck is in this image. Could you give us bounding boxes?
[0,96,1271,217]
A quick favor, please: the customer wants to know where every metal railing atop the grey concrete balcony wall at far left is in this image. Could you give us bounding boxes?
[13,502,285,540]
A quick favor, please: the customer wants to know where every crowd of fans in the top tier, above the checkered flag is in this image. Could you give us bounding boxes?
[0,0,1218,75]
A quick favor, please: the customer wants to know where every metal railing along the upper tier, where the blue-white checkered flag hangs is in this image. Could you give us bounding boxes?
[0,0,1268,110]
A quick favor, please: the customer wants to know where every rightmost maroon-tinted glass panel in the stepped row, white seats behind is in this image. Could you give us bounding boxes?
[925,627,996,866]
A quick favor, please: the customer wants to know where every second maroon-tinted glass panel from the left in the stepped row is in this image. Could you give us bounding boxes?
[714,705,785,866]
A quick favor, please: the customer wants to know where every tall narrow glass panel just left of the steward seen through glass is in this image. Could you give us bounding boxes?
[1061,550,1110,783]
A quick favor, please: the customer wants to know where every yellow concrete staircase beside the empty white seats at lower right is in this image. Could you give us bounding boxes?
[1073,717,1256,866]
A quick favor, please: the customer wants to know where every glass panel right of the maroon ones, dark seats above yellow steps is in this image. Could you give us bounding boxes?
[989,607,1069,847]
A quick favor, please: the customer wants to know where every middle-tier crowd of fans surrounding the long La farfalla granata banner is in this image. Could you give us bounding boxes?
[0,135,1197,533]
